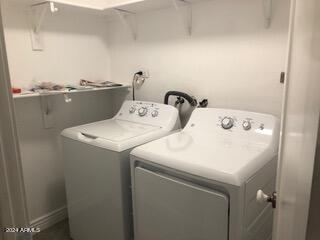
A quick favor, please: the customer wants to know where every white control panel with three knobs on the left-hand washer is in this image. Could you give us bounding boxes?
[115,101,180,128]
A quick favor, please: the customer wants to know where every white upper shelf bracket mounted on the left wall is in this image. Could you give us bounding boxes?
[29,2,58,51]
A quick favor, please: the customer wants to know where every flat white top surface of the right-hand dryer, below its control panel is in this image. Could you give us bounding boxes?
[131,131,277,186]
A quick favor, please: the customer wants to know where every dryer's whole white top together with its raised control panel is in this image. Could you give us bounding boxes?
[131,109,279,186]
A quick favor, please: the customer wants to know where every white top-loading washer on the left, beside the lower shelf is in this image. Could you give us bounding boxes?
[62,101,180,240]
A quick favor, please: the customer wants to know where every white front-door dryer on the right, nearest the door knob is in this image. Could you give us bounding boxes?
[131,109,279,240]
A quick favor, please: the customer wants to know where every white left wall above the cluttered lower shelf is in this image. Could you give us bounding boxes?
[2,0,110,87]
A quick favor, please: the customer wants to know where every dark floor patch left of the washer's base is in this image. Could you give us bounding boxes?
[33,220,71,240]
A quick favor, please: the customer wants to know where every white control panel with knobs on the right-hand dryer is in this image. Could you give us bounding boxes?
[183,108,280,148]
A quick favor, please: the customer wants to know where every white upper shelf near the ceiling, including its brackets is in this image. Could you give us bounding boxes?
[28,0,274,47]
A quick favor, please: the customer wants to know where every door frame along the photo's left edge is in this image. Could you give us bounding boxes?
[0,0,29,240]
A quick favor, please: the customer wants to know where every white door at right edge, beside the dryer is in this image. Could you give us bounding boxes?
[273,0,320,240]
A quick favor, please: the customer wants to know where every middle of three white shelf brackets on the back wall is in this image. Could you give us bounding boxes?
[172,0,193,36]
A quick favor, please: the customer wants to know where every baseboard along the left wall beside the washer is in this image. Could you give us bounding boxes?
[30,206,68,231]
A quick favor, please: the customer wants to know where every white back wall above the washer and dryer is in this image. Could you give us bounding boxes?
[108,0,289,116]
